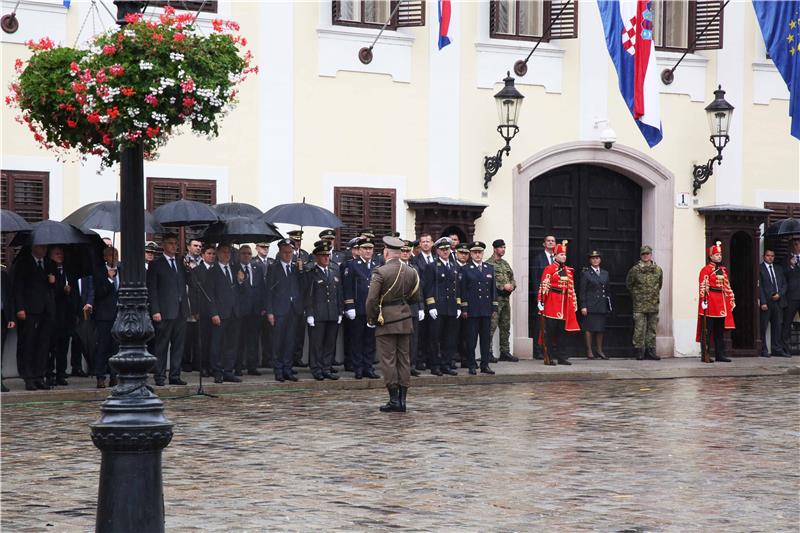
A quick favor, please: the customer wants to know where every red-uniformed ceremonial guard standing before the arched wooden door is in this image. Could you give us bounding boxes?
[539,241,581,365]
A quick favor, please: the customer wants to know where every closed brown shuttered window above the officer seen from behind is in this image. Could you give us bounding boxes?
[333,187,397,252]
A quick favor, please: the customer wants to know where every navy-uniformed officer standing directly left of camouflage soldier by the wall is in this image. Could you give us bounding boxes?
[461,241,497,375]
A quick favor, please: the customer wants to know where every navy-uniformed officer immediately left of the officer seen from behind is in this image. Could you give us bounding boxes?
[342,239,380,379]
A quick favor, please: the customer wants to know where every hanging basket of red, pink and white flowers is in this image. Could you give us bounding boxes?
[6,7,258,166]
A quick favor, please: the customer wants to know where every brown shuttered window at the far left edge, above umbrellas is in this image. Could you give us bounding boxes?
[0,169,50,266]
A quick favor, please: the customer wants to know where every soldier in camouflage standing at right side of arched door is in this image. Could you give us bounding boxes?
[625,245,664,360]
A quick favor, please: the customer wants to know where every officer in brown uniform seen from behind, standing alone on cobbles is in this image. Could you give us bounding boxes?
[366,237,420,412]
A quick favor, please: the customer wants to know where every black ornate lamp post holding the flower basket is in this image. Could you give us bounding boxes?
[91,0,172,533]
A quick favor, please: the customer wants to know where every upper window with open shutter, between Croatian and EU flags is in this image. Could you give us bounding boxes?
[650,0,724,52]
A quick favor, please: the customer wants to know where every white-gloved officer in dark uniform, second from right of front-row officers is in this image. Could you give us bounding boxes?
[422,237,461,376]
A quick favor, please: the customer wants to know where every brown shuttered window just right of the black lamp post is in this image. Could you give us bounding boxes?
[147,178,217,249]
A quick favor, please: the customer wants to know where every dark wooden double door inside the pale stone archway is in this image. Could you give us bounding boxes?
[528,165,658,356]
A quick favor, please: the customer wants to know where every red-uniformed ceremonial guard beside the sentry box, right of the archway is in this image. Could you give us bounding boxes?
[697,241,736,363]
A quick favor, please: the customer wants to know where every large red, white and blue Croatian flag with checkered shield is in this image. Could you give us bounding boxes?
[597,0,664,148]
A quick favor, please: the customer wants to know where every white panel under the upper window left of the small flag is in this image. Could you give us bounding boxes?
[317,25,415,83]
